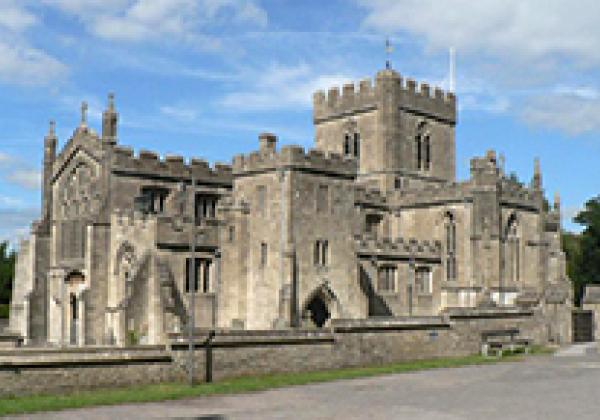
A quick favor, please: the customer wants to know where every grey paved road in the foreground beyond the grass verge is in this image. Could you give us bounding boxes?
[10,347,600,420]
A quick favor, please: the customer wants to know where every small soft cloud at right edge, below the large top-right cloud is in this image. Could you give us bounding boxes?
[521,94,600,136]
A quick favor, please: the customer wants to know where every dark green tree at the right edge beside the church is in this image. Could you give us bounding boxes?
[565,195,600,302]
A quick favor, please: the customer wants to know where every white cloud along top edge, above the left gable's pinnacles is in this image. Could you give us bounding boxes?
[44,0,267,49]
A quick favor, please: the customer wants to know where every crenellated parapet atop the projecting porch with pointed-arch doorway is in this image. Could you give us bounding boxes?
[233,146,356,178]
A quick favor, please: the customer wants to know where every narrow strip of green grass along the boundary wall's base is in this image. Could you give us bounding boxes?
[0,348,546,416]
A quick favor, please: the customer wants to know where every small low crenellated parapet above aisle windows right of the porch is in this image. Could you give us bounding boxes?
[354,235,442,260]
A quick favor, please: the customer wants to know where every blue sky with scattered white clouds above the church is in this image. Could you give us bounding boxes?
[0,0,600,243]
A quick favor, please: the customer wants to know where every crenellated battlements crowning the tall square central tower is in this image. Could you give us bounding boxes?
[313,70,456,125]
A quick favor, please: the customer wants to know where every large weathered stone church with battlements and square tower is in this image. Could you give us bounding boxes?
[9,65,571,346]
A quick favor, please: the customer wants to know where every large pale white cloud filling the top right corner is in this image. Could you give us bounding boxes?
[359,0,600,64]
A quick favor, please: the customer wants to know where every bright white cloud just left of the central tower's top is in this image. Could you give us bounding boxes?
[220,63,356,111]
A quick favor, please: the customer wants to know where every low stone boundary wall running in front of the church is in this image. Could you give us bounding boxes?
[0,310,564,398]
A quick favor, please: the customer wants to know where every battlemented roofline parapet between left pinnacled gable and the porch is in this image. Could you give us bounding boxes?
[111,146,233,185]
